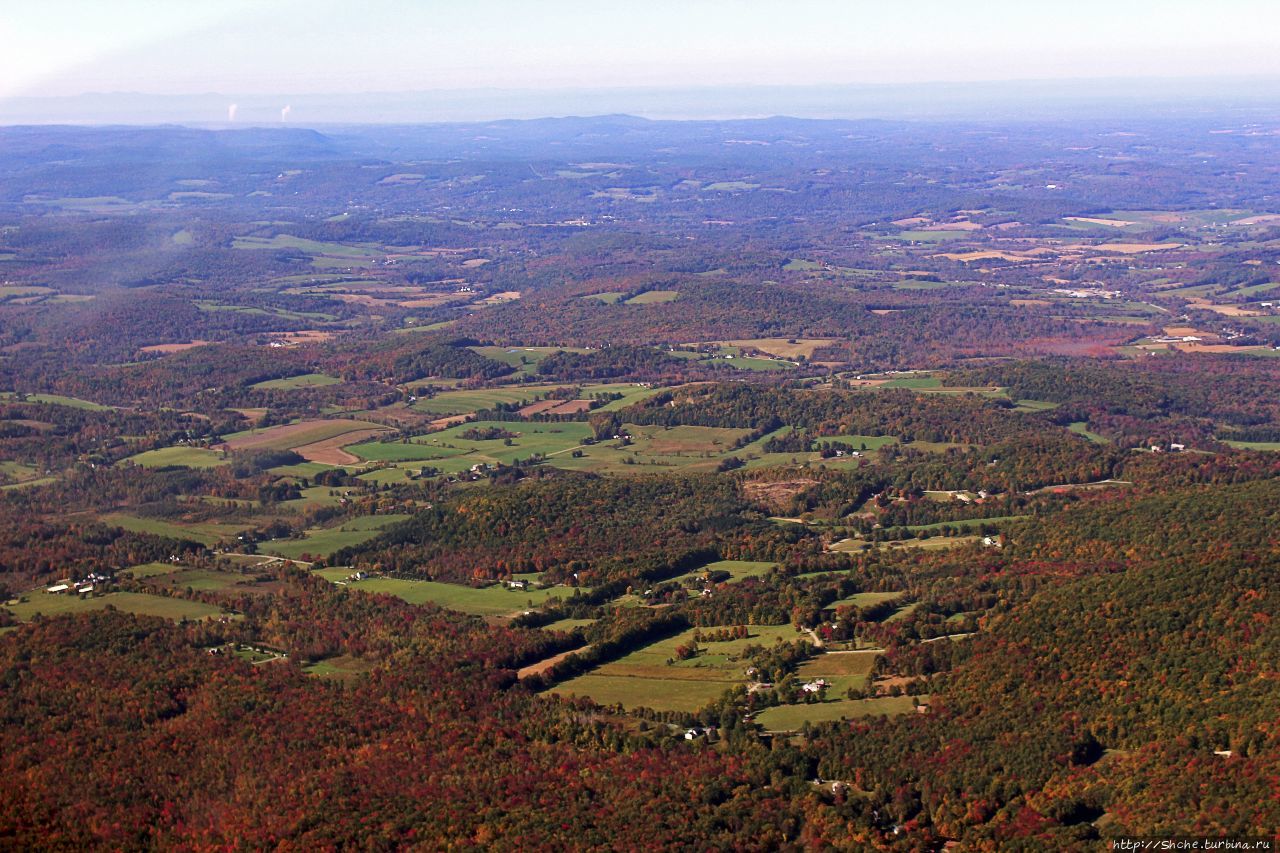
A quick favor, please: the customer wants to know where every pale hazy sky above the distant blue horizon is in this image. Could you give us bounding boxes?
[0,0,1280,96]
